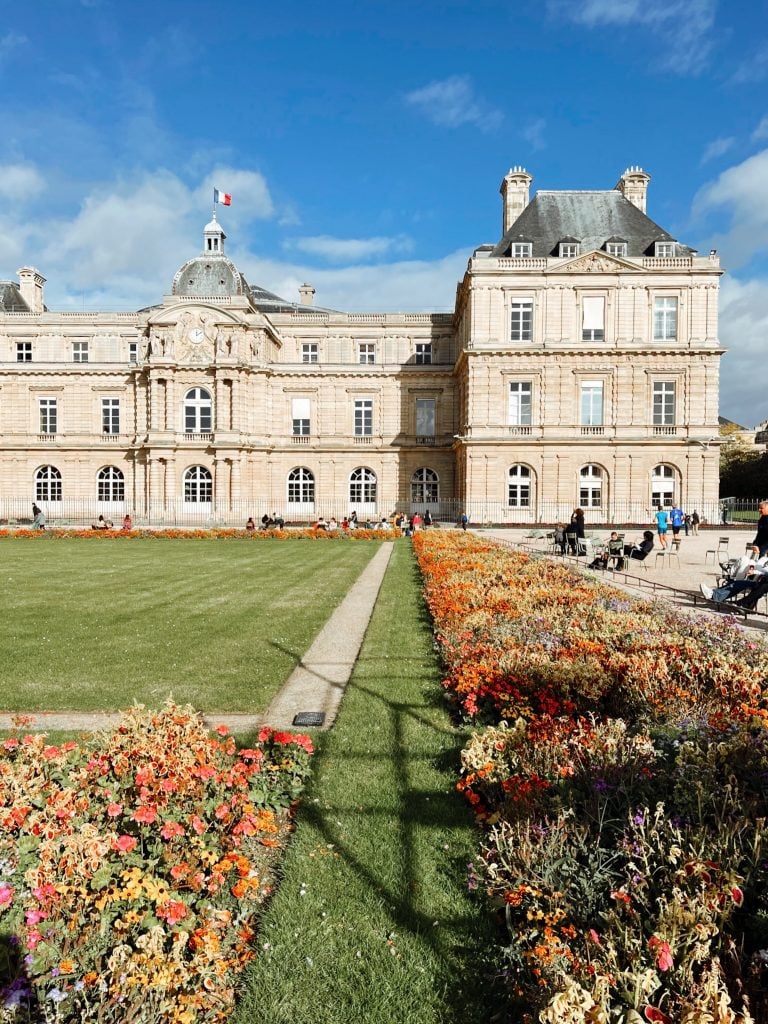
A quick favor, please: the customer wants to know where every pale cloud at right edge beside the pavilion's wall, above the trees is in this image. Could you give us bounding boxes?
[720,276,768,426]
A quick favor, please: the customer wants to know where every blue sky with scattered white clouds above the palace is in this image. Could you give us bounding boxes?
[0,0,768,425]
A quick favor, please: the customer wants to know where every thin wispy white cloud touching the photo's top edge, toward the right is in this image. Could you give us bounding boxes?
[548,0,717,75]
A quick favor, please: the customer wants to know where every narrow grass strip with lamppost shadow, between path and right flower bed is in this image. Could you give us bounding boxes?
[232,545,499,1024]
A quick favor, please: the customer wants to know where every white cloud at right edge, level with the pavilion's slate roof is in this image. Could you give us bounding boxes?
[693,150,768,267]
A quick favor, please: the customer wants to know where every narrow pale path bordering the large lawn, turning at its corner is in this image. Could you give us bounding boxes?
[0,542,394,733]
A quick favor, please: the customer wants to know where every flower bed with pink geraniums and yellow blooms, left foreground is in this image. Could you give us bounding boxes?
[0,702,312,1024]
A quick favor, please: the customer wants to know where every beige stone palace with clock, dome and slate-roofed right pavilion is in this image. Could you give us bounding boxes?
[0,168,722,523]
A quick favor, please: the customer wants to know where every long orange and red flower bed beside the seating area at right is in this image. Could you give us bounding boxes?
[414,534,768,1024]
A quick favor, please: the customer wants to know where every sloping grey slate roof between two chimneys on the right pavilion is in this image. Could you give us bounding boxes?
[493,189,695,257]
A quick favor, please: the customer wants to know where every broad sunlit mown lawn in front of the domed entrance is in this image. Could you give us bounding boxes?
[0,539,379,712]
